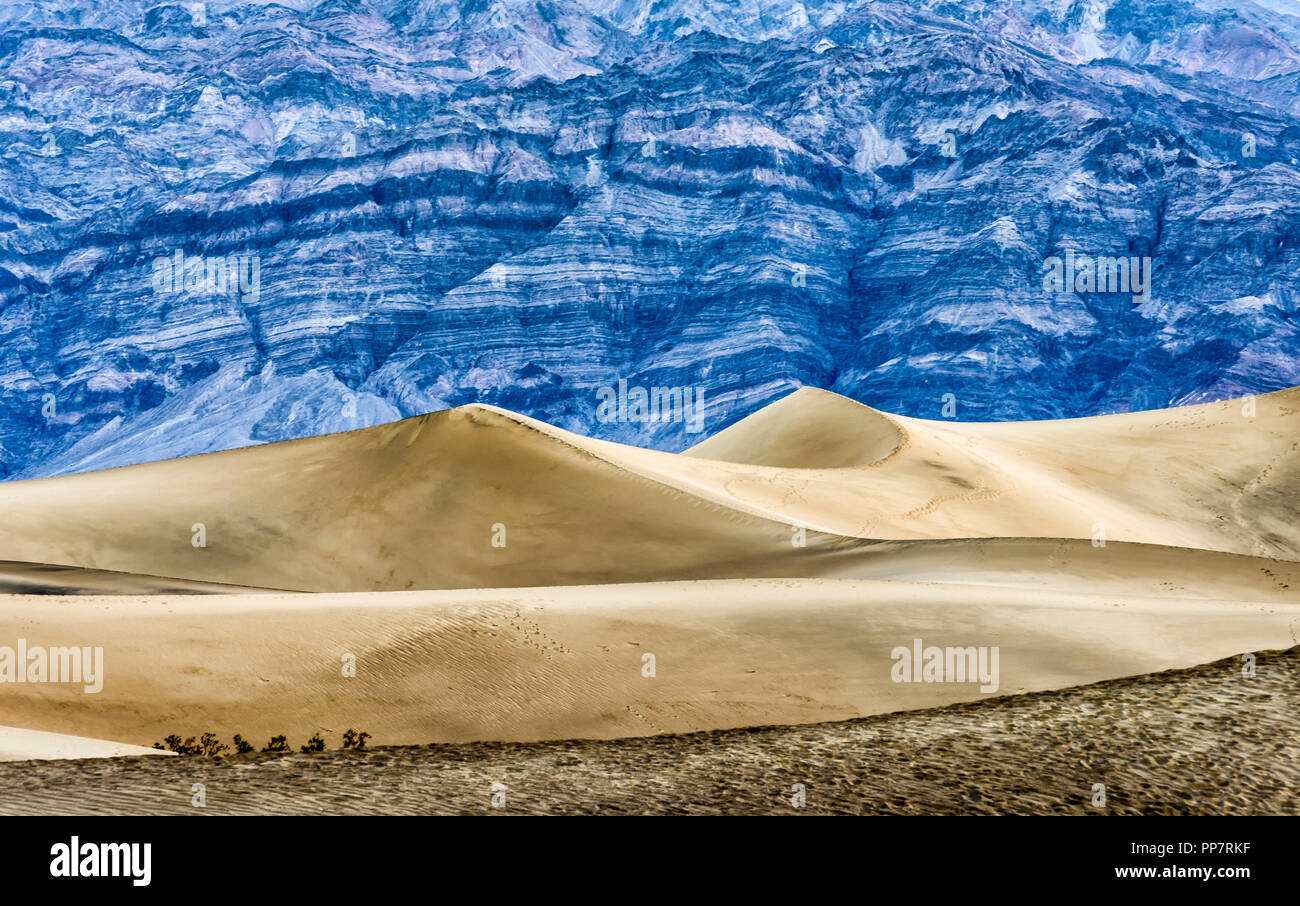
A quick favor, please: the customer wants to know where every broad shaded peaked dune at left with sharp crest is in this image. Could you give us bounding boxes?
[0,407,821,591]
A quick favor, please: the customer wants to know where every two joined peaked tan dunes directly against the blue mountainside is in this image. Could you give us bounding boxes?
[0,390,1300,591]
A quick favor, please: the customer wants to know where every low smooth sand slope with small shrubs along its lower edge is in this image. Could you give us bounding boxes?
[0,580,1300,746]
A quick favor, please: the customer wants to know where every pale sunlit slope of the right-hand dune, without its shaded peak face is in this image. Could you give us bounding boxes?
[670,389,1300,560]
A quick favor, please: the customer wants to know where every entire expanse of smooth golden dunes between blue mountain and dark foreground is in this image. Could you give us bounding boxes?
[0,389,1300,757]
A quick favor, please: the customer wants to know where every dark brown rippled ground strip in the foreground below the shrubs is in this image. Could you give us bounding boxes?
[0,647,1300,815]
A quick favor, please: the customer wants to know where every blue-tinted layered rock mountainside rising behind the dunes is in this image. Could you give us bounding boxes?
[0,0,1300,478]
